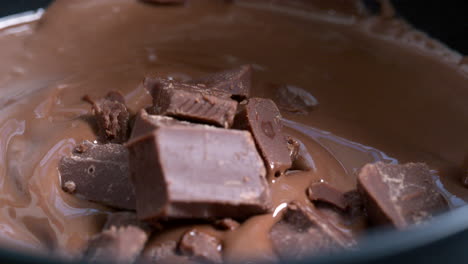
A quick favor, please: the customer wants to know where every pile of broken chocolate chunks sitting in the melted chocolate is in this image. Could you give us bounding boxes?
[59,65,447,263]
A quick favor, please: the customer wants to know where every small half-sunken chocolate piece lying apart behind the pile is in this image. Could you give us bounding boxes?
[276,85,318,114]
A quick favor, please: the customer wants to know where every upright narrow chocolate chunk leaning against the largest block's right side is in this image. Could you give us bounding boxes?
[234,98,291,178]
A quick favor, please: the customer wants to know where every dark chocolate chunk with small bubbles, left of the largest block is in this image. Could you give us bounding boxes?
[59,141,135,210]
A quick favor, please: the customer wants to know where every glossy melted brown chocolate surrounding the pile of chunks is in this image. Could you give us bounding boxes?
[0,0,468,260]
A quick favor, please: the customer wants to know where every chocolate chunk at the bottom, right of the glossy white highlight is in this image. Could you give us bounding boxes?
[270,202,354,261]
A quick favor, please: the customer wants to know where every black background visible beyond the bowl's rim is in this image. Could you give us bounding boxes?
[0,0,468,54]
